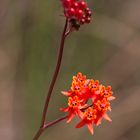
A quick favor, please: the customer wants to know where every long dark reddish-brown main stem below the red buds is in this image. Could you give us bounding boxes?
[33,19,71,140]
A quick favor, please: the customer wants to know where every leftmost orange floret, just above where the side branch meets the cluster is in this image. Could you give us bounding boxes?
[60,96,87,122]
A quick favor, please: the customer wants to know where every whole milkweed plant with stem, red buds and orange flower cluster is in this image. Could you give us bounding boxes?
[33,0,115,140]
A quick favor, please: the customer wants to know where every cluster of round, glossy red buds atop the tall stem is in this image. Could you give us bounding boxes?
[61,0,91,30]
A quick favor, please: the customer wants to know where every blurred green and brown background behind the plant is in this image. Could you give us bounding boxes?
[0,0,140,140]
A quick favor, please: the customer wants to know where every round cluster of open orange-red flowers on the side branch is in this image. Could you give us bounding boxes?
[60,72,115,134]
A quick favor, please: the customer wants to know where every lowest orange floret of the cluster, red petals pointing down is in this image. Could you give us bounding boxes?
[76,107,96,135]
